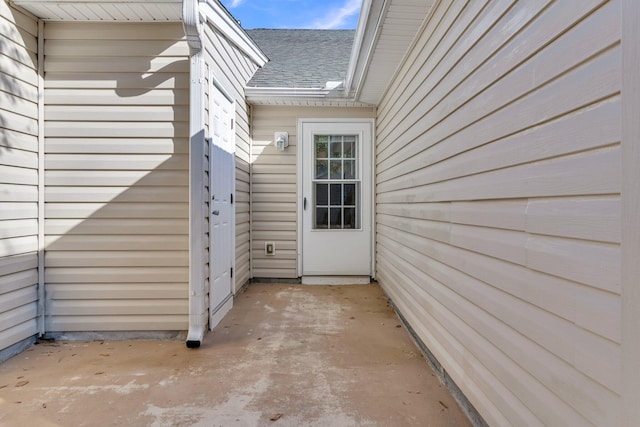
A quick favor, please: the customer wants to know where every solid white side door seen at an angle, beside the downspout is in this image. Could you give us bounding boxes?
[209,85,235,328]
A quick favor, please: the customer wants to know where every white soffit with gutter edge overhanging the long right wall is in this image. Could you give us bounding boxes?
[348,0,436,105]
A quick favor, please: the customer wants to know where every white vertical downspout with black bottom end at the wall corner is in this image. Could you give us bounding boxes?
[182,0,208,348]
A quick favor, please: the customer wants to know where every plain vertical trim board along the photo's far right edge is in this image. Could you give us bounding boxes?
[621,0,640,426]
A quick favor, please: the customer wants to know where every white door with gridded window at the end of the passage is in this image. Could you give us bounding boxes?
[300,121,373,283]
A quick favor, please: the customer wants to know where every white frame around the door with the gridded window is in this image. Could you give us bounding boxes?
[296,118,376,279]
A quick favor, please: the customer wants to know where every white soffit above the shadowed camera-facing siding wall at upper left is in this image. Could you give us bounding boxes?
[12,0,182,22]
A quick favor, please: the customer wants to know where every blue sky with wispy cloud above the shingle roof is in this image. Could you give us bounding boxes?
[221,0,362,29]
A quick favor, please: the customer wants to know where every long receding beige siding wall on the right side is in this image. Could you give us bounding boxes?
[376,0,621,426]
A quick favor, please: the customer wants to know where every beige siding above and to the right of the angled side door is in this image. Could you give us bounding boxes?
[203,26,258,291]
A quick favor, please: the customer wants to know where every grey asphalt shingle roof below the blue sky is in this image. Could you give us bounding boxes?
[247,29,355,88]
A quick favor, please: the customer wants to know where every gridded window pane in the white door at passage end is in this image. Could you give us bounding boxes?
[313,135,360,230]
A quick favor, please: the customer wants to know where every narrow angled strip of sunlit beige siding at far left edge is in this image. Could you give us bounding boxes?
[0,1,38,351]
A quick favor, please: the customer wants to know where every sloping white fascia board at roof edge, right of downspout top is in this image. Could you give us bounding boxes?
[200,0,269,67]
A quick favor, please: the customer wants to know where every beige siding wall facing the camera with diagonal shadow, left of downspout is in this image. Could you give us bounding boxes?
[44,22,189,332]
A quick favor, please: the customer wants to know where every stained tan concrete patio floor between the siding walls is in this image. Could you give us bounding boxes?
[0,284,470,427]
